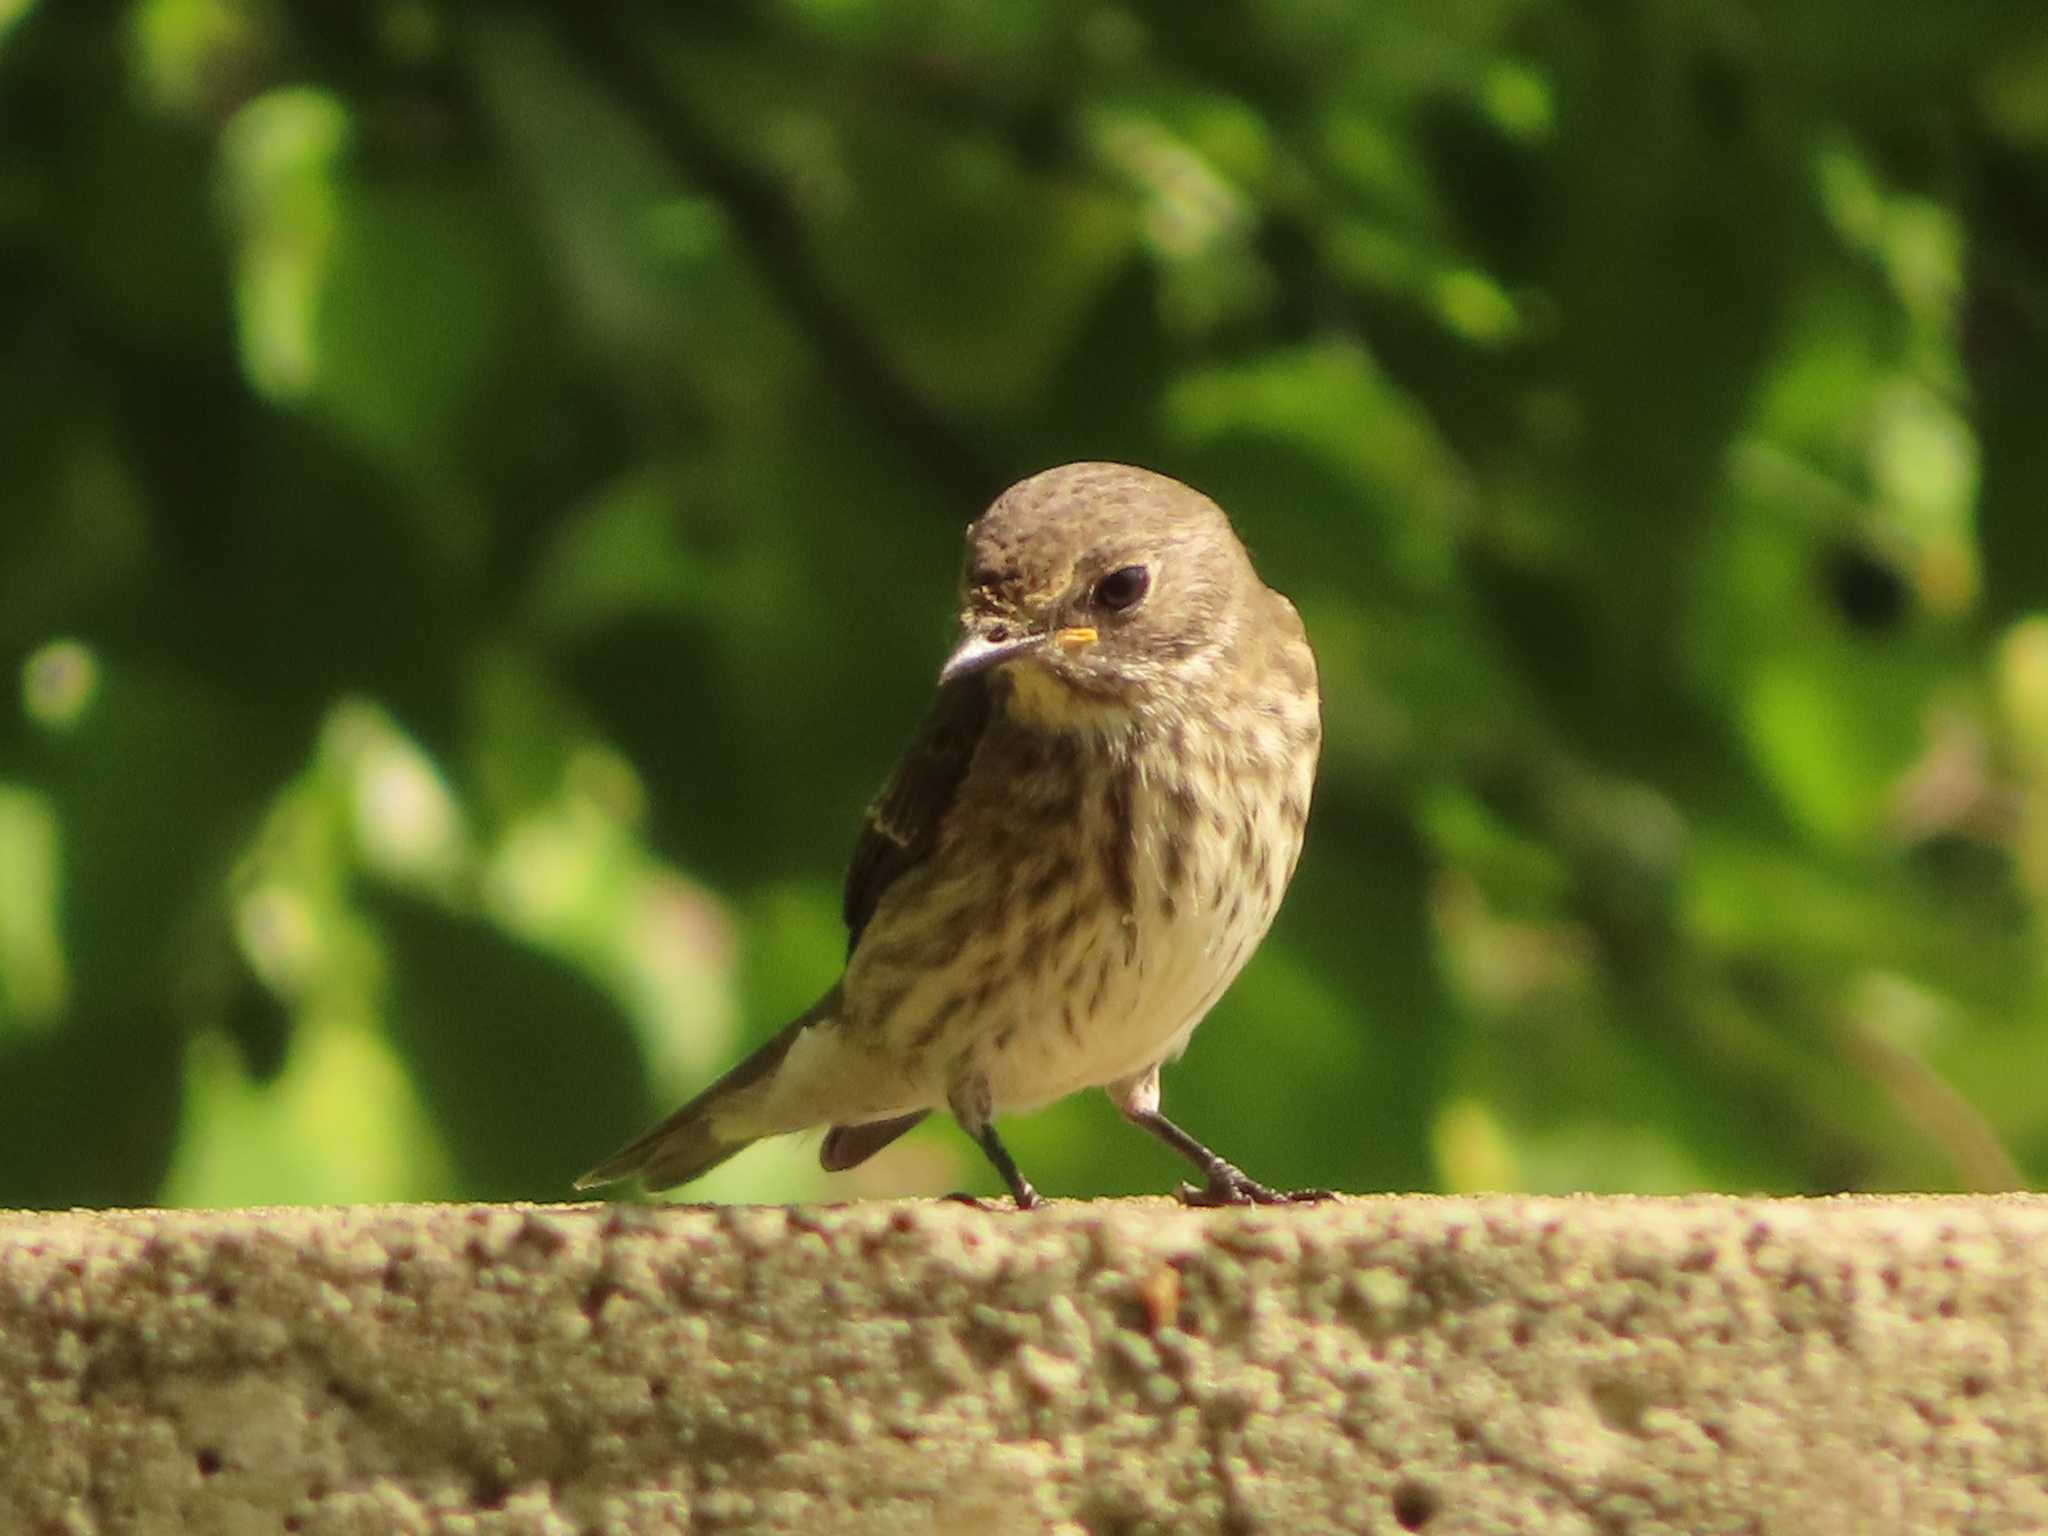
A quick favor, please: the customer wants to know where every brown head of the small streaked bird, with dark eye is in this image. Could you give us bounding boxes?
[940,463,1264,727]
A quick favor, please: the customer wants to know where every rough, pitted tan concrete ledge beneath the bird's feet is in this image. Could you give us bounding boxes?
[0,1196,2048,1536]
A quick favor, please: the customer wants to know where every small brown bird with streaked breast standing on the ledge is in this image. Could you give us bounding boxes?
[578,463,1323,1206]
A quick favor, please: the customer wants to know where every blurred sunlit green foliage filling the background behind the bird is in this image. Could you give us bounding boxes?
[0,0,2048,1204]
